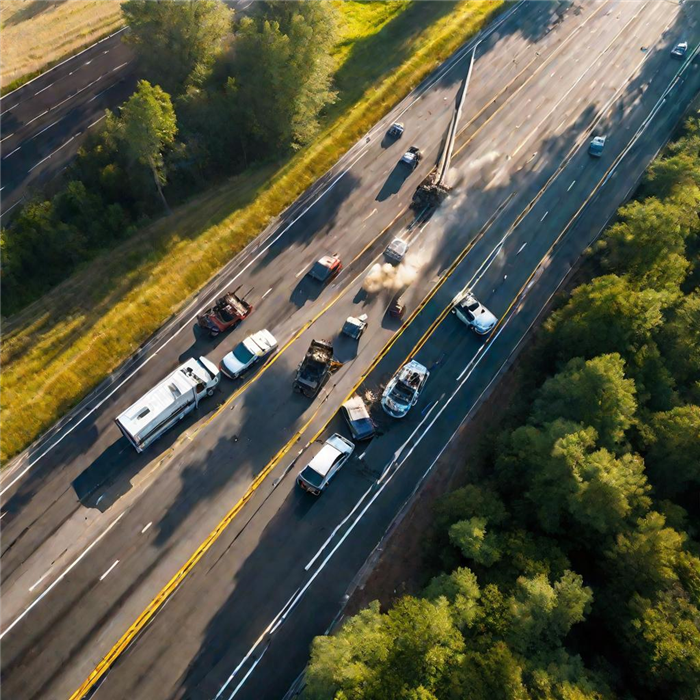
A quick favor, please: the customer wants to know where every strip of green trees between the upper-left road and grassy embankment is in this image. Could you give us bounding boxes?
[0,0,336,314]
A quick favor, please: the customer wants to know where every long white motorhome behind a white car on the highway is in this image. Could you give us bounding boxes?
[116,357,221,452]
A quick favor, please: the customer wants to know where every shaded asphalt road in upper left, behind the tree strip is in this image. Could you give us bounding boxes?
[0,0,254,220]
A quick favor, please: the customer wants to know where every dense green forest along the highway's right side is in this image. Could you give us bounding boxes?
[305,118,700,700]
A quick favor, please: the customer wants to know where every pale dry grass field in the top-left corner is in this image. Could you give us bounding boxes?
[0,0,122,94]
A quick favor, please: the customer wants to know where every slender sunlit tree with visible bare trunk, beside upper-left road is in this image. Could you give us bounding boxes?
[107,80,177,211]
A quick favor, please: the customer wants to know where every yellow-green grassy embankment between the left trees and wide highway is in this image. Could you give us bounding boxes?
[0,0,508,462]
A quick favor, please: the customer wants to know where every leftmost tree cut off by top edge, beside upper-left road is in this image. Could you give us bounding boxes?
[122,0,233,94]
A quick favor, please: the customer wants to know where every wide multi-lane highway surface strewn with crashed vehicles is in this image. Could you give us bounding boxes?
[0,0,700,699]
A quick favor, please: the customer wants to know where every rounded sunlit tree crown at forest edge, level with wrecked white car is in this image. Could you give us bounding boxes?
[532,353,637,449]
